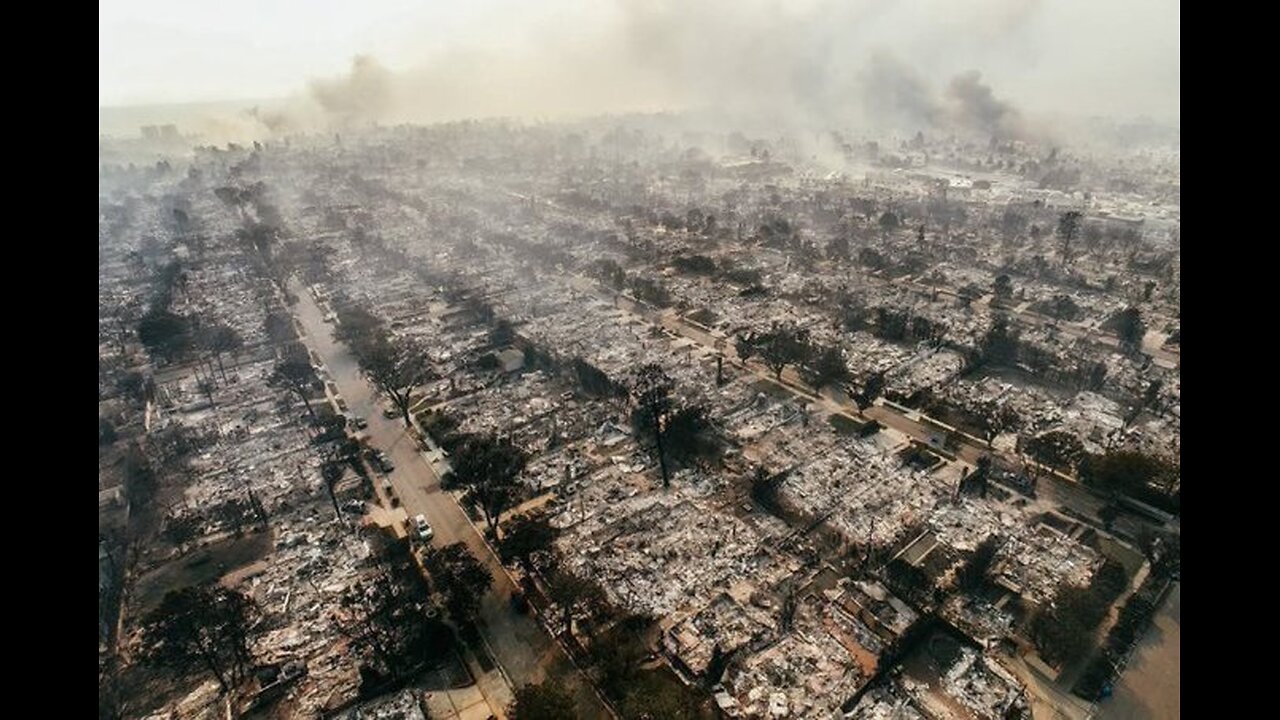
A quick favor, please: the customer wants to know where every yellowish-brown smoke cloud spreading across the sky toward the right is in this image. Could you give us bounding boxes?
[97,0,1179,138]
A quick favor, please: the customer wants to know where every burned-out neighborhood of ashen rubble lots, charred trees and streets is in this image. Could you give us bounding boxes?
[99,5,1181,720]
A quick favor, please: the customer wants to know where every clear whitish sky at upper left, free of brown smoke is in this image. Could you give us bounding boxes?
[97,0,590,105]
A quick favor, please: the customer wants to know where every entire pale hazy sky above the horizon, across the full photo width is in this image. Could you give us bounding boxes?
[99,0,1180,120]
